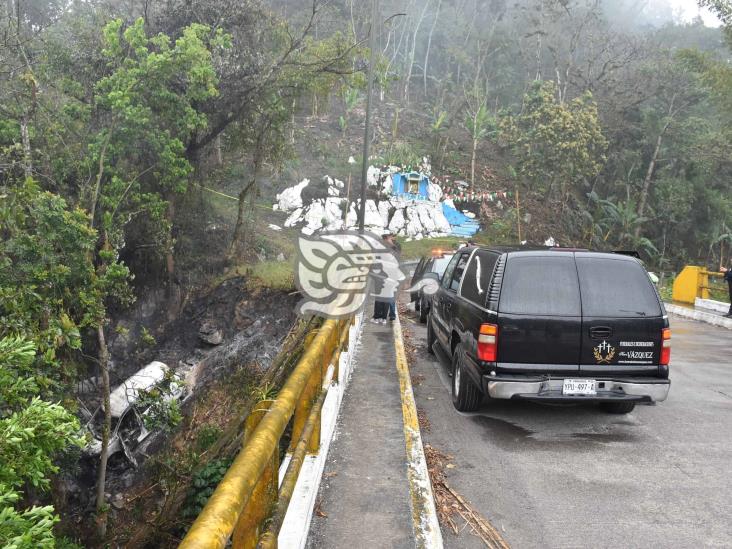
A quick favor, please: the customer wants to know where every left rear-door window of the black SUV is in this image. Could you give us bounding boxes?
[498,255,582,316]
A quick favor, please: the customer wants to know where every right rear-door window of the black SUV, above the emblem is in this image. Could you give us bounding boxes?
[577,257,661,318]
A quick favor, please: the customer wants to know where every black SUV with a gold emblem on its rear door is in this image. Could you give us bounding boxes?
[427,247,671,413]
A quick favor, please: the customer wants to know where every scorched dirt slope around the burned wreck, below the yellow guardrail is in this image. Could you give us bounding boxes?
[62,277,298,547]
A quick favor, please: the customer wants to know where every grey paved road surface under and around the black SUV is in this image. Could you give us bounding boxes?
[402,308,732,549]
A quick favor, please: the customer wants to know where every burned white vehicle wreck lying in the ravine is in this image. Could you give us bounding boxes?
[82,361,186,467]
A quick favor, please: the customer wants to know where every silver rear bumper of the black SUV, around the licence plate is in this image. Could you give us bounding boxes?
[482,375,671,402]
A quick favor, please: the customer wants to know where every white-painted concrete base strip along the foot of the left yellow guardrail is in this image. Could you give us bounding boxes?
[277,312,363,549]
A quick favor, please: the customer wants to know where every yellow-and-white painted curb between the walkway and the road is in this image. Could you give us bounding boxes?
[393,313,442,549]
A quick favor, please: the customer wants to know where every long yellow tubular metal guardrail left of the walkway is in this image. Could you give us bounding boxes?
[179,319,353,549]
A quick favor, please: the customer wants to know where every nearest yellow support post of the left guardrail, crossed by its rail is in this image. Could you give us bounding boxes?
[231,400,280,549]
